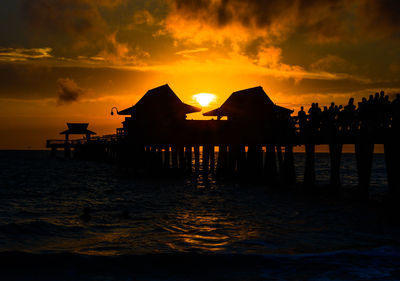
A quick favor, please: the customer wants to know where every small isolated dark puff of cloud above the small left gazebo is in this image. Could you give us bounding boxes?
[57,78,88,105]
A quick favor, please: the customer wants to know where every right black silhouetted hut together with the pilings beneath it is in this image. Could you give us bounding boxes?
[203,87,295,183]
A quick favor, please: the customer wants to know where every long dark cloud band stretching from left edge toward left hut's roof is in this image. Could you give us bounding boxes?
[0,61,157,100]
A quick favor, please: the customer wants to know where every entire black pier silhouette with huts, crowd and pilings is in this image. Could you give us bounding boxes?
[47,85,400,197]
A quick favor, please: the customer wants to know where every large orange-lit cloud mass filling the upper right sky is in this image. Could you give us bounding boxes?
[158,0,400,81]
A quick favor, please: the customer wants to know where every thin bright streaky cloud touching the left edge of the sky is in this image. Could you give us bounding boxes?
[0,48,52,62]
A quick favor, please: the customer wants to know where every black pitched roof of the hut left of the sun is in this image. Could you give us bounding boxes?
[118,84,201,115]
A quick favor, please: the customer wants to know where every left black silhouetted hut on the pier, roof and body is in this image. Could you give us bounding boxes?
[117,84,201,142]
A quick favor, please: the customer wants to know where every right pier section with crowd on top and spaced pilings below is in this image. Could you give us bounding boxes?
[296,91,400,196]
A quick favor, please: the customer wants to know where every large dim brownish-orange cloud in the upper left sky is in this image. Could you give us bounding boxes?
[21,0,155,66]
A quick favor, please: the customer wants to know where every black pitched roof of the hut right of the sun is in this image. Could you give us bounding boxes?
[203,86,293,121]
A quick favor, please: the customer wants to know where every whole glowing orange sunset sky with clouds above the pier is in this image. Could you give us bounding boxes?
[0,0,400,149]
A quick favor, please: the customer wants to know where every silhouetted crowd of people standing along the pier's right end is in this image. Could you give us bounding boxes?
[295,91,400,133]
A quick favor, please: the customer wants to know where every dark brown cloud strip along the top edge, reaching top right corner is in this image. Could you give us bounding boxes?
[170,0,400,42]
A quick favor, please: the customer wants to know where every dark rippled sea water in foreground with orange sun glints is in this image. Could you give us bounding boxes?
[0,151,400,280]
